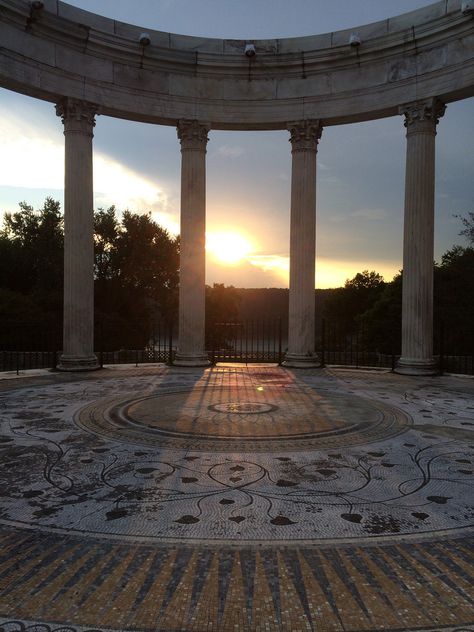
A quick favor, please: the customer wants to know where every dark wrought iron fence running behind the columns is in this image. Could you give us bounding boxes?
[0,319,474,375]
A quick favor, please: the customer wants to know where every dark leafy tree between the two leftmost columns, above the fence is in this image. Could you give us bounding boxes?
[94,206,179,348]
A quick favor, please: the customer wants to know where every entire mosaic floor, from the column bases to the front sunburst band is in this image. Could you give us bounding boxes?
[0,365,474,632]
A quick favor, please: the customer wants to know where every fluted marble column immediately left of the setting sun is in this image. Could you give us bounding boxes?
[174,120,209,366]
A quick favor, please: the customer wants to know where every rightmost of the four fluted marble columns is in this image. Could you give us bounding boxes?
[396,99,445,375]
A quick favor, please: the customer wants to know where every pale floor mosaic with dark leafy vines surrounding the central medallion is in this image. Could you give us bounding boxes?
[0,369,474,542]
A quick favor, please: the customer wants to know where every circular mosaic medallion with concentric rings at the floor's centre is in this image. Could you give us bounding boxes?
[75,386,411,452]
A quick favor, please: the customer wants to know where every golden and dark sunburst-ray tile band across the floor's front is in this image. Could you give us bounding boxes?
[0,532,474,631]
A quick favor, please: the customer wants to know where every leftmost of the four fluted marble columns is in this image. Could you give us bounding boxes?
[56,99,99,371]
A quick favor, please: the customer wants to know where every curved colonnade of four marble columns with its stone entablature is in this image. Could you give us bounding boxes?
[0,0,474,375]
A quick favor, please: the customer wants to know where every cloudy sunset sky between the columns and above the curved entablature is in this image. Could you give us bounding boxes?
[0,0,474,287]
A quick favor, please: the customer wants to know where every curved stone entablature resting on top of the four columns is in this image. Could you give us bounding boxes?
[0,0,474,129]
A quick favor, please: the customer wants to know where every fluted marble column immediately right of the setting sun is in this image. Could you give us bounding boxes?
[284,120,322,368]
